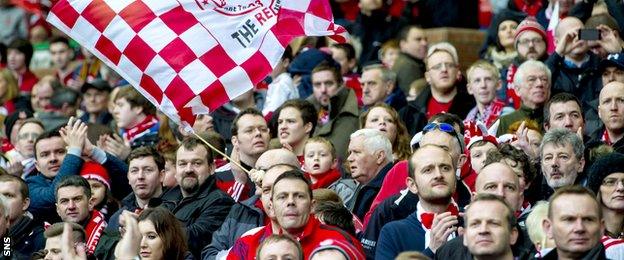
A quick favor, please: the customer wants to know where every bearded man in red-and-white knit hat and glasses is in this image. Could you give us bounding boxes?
[498,17,548,109]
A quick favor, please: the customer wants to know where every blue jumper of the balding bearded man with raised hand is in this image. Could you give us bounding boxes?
[375,212,433,260]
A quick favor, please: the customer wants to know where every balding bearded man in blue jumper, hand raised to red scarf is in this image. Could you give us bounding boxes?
[375,145,459,259]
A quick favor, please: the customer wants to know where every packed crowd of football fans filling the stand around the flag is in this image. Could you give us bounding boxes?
[0,0,624,259]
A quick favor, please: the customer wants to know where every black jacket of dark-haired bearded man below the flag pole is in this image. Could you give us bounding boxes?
[163,176,234,259]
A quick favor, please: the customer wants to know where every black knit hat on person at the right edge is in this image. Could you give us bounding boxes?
[587,152,624,193]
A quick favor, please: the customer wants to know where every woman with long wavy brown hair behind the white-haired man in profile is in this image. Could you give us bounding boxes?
[360,104,410,162]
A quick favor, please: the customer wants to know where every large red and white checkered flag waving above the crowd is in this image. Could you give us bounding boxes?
[48,0,347,125]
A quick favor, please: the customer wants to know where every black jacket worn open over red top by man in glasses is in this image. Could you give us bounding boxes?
[399,86,475,136]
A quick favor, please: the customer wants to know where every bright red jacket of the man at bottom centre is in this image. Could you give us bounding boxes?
[227,215,365,260]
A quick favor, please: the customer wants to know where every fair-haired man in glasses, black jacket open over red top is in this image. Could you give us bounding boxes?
[399,42,475,135]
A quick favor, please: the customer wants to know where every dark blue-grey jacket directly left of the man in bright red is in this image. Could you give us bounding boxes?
[202,195,264,259]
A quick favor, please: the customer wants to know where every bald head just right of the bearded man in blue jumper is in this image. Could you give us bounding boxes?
[475,162,524,210]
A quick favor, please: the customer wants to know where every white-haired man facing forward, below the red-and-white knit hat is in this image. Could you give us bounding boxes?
[492,60,551,136]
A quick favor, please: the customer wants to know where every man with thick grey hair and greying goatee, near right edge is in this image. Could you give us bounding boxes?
[537,129,585,200]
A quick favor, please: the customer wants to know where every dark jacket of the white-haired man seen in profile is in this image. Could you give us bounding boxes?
[351,163,394,219]
